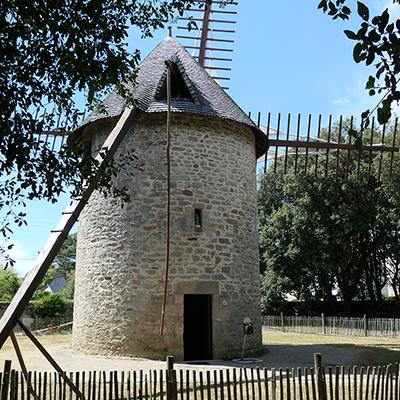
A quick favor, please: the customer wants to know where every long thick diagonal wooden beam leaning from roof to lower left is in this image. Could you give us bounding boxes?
[0,108,134,349]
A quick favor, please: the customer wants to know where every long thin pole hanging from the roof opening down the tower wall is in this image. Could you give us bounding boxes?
[160,61,171,336]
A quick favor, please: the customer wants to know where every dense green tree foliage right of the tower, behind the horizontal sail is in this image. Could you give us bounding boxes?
[258,122,400,314]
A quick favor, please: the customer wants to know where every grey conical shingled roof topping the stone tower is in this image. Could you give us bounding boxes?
[75,37,266,157]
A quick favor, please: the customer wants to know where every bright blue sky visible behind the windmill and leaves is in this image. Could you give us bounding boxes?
[11,0,400,275]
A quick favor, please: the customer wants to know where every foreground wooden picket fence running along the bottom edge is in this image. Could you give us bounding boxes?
[0,358,399,400]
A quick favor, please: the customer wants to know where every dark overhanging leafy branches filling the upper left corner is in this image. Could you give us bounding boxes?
[0,0,192,268]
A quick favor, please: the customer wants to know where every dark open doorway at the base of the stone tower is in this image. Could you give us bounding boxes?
[183,294,212,361]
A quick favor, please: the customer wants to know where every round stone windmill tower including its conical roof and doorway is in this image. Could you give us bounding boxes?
[73,38,265,360]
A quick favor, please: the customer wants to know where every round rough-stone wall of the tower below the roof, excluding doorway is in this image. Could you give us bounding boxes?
[73,113,261,359]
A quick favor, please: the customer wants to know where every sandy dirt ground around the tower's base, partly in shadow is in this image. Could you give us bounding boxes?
[0,331,400,371]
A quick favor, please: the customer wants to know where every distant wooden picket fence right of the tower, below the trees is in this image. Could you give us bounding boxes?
[262,314,400,338]
